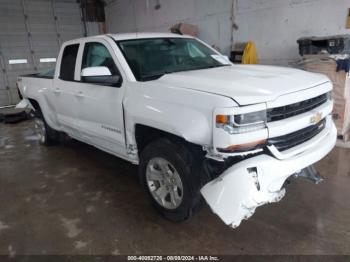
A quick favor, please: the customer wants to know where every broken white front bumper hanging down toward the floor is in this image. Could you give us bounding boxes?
[201,120,337,228]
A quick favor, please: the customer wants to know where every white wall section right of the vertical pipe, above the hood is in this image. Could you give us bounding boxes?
[234,0,350,65]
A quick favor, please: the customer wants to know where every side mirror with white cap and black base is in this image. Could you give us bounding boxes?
[80,66,122,87]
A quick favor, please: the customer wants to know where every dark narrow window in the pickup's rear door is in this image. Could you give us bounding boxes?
[60,44,79,81]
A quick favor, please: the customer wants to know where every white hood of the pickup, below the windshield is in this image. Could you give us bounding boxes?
[156,65,329,105]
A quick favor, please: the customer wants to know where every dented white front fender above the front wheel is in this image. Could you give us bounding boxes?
[123,83,235,145]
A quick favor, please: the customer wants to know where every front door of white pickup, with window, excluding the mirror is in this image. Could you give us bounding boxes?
[76,39,126,155]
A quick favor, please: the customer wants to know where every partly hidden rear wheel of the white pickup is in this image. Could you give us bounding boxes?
[35,110,58,146]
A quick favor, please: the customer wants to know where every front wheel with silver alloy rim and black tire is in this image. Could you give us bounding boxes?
[139,138,203,222]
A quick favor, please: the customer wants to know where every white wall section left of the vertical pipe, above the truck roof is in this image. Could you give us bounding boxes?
[105,0,232,54]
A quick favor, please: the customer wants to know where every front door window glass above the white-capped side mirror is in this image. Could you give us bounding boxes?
[81,42,119,75]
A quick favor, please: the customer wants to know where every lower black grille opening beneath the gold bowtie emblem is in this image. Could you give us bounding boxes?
[268,118,326,151]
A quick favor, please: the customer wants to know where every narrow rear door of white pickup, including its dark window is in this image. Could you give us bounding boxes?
[51,43,80,138]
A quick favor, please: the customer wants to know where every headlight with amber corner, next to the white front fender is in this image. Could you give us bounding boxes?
[216,110,267,134]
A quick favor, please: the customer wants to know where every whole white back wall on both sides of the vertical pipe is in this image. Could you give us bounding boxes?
[106,0,350,65]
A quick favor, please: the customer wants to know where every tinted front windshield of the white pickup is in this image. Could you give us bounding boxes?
[117,38,230,81]
